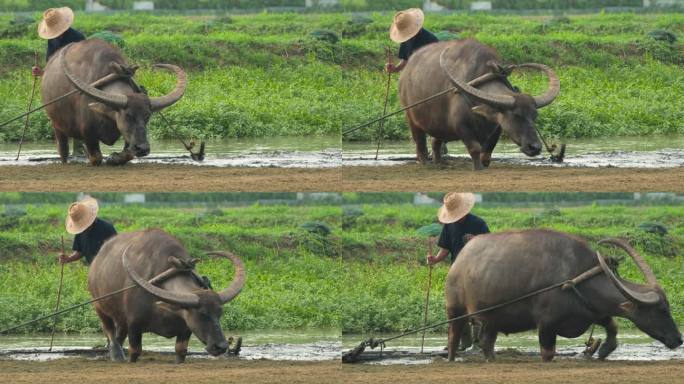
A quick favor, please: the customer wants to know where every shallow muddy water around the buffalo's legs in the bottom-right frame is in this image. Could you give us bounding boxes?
[342,330,684,365]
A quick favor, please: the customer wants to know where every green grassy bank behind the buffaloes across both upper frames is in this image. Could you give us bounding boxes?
[0,13,684,141]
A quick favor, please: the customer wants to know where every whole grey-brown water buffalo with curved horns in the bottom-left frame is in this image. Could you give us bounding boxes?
[88,229,245,363]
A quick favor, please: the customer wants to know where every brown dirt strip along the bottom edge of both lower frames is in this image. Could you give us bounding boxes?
[0,357,684,384]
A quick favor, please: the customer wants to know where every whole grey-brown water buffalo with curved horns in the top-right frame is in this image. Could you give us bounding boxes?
[399,40,560,170]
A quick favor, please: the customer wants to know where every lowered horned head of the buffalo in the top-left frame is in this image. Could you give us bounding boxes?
[59,47,187,157]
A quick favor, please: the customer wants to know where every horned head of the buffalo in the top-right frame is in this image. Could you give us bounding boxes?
[440,49,560,156]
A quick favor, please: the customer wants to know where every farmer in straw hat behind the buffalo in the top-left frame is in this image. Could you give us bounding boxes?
[32,7,86,76]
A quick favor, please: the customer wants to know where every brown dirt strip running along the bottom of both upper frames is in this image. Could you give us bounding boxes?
[0,163,684,192]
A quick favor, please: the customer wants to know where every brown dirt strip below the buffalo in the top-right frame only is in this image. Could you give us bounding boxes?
[341,163,684,192]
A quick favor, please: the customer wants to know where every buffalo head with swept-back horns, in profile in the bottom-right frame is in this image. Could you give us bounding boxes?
[596,239,682,349]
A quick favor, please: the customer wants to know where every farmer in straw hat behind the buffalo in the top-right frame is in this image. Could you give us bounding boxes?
[385,8,439,73]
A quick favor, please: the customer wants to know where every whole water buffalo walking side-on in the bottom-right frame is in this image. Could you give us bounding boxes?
[445,230,682,361]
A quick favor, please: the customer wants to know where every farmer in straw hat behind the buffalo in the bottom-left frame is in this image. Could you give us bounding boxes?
[59,196,116,265]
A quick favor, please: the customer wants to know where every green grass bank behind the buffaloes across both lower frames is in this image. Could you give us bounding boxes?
[0,200,684,333]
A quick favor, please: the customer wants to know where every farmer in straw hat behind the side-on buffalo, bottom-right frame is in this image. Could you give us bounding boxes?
[427,192,489,350]
